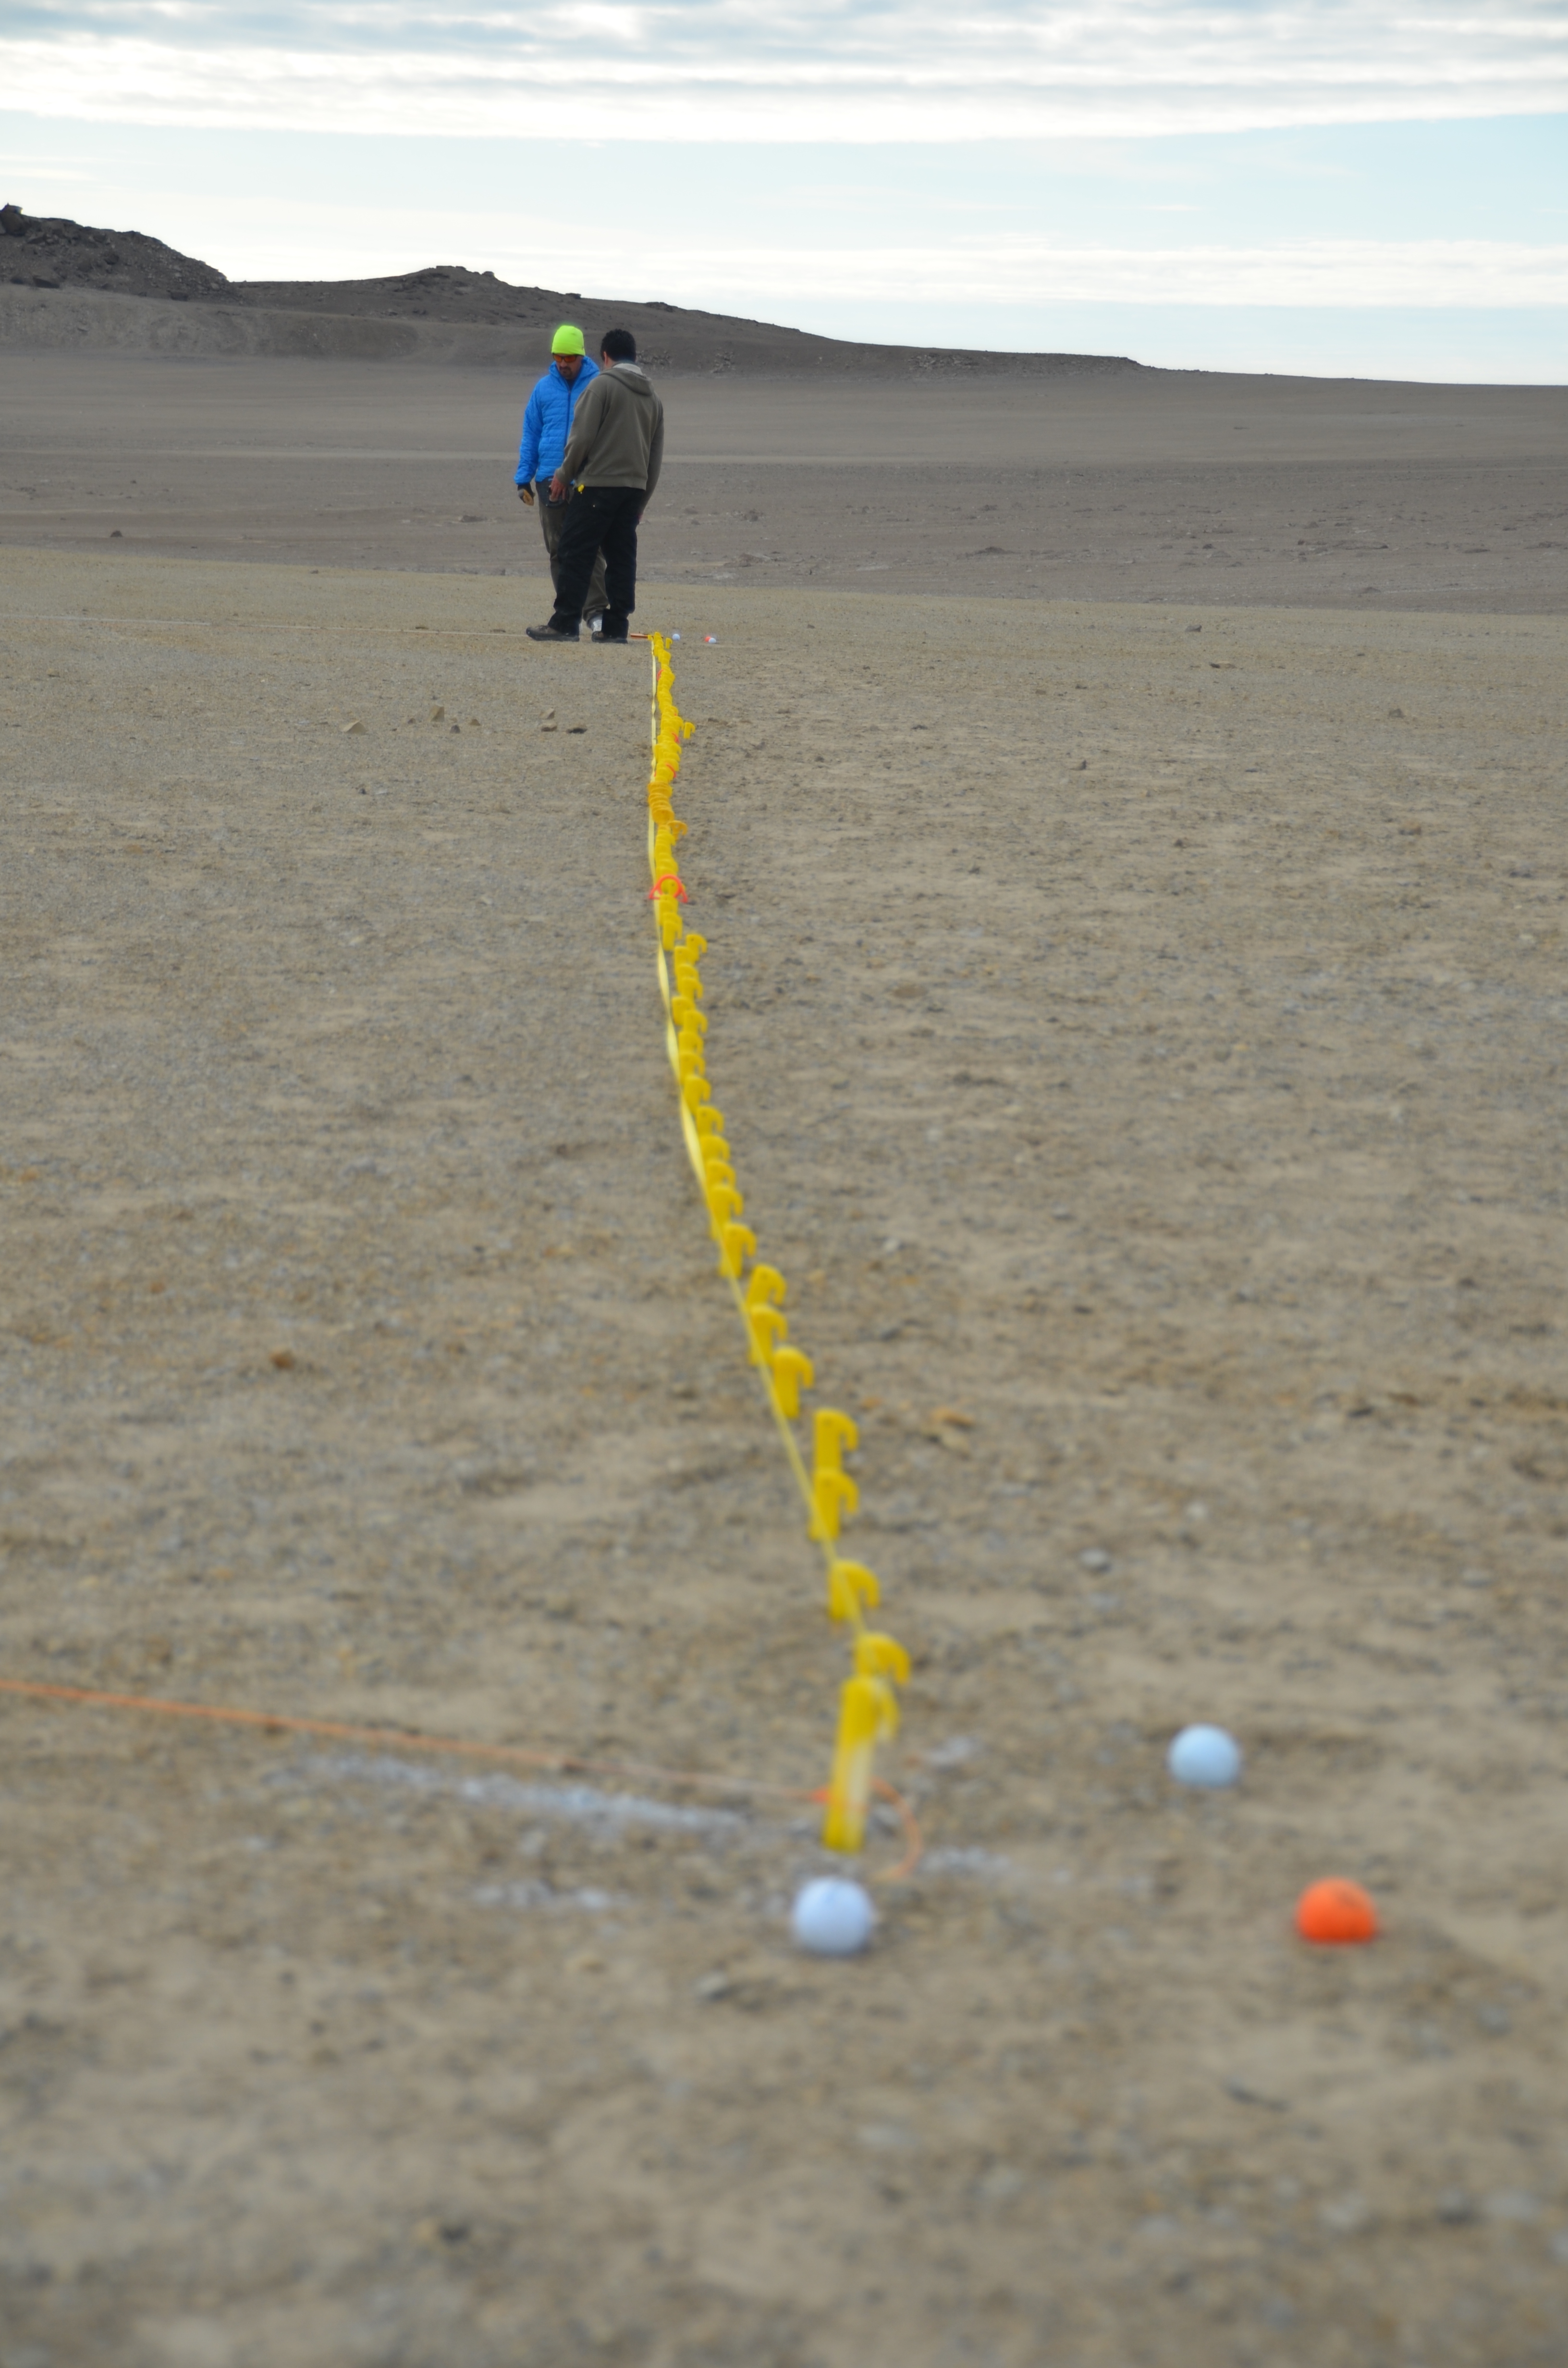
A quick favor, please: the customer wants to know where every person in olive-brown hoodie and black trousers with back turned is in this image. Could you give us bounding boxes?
[528,329,663,644]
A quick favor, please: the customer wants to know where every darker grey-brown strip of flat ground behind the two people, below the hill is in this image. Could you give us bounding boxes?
[0,348,1568,630]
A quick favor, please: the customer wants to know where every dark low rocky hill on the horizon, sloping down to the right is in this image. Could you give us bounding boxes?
[0,206,1139,377]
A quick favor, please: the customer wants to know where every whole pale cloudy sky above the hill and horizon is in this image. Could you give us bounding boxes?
[0,0,1568,381]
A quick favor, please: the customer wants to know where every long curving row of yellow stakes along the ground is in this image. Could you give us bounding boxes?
[649,632,909,1850]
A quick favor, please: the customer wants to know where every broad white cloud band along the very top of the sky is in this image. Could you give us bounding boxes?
[0,0,1568,142]
